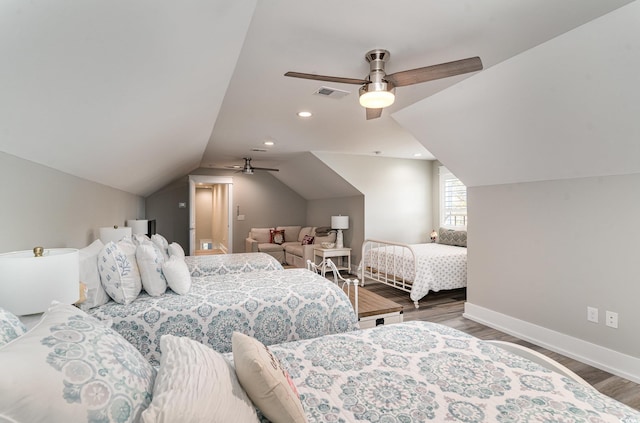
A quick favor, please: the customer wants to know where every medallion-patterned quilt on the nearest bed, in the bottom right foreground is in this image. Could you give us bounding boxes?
[263,321,640,423]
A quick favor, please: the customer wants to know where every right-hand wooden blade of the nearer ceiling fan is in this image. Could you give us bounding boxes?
[385,56,482,87]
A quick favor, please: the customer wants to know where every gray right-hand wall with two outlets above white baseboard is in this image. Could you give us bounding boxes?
[467,174,640,357]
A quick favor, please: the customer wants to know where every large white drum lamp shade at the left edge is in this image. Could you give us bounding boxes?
[0,248,80,316]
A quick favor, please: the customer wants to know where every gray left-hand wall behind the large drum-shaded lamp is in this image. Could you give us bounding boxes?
[0,152,145,252]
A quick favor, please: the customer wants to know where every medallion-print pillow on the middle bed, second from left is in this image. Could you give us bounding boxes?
[98,239,142,304]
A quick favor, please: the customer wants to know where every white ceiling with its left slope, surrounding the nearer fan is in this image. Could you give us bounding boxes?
[0,0,629,195]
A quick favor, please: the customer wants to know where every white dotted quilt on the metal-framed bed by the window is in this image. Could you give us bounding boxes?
[364,243,467,302]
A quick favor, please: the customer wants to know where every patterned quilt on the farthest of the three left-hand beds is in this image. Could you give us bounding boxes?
[184,253,283,277]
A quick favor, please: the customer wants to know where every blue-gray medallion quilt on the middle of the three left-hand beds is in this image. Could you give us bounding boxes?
[88,269,358,365]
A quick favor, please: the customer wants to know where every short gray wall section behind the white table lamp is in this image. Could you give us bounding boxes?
[307,195,364,273]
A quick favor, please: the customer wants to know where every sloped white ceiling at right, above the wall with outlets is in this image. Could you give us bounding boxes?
[393,1,640,186]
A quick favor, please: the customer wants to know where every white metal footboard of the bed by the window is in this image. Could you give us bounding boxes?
[358,239,420,308]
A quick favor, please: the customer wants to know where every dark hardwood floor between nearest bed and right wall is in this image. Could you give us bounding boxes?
[365,282,640,410]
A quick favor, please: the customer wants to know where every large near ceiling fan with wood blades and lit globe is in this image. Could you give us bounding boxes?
[284,49,482,119]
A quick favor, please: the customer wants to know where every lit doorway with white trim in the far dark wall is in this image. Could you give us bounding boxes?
[189,175,233,255]
